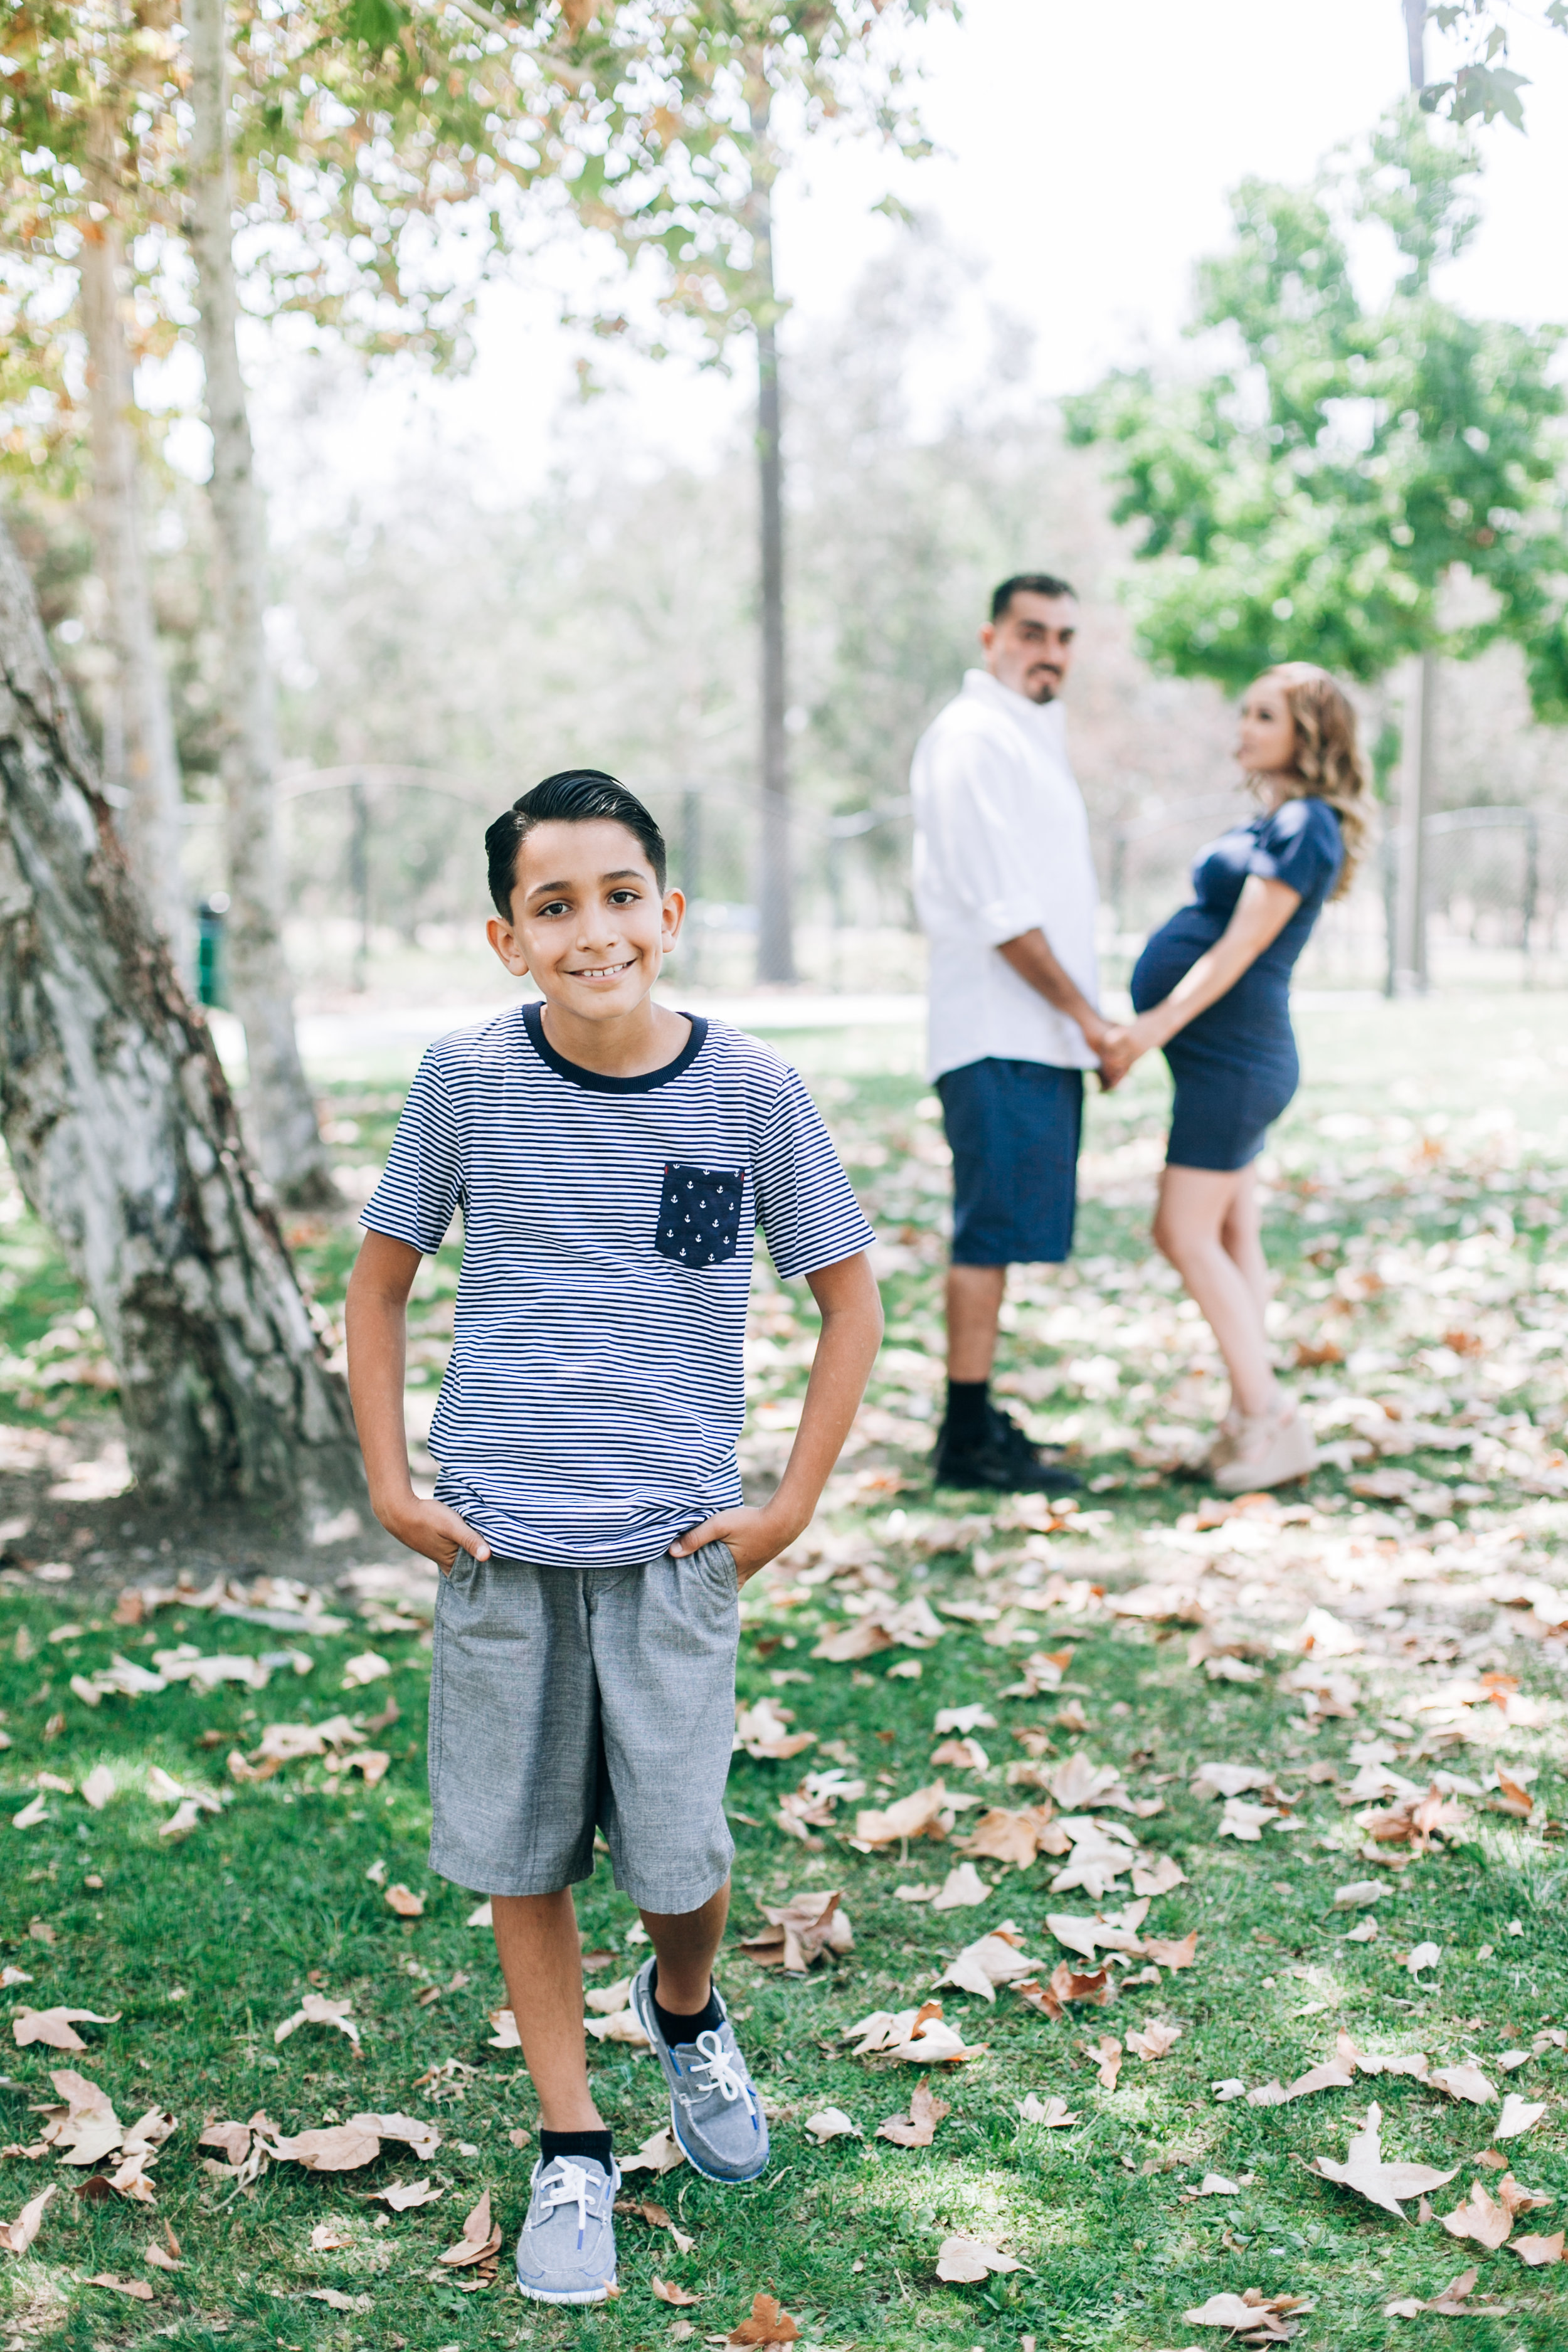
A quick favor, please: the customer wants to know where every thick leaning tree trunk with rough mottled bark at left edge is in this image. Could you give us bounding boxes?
[0,508,364,1510]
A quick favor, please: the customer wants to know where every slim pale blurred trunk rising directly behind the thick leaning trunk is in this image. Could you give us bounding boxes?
[78,122,191,967]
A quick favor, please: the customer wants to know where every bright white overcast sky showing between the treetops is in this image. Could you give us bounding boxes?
[266,0,1568,529]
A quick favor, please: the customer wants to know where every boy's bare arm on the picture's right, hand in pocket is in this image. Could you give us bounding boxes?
[670,1249,882,1583]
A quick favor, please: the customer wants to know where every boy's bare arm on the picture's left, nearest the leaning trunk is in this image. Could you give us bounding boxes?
[346,1232,489,1576]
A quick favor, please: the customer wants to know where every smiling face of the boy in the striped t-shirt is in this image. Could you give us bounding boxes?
[487,818,686,1021]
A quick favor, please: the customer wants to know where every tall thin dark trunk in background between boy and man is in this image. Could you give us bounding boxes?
[748,92,795,981]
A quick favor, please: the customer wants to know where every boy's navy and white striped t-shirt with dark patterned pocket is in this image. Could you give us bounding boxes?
[362,1002,872,1567]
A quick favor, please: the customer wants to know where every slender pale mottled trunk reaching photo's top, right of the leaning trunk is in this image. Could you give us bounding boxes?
[186,0,336,1207]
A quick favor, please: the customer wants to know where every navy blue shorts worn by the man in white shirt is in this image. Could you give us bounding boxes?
[936,1056,1084,1266]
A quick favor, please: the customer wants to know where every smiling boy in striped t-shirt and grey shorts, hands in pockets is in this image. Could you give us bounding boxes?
[348,769,882,2302]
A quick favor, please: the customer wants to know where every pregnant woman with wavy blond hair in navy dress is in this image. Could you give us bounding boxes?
[1105,661,1368,1493]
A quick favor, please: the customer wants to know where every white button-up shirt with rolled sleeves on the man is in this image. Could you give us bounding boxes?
[910,670,1100,1078]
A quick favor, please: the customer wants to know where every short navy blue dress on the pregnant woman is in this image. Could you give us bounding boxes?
[1133,800,1345,1169]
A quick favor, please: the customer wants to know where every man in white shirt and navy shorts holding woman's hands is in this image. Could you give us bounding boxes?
[910,571,1119,1493]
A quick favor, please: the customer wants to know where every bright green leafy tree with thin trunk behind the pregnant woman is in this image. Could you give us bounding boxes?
[1067,106,1568,978]
